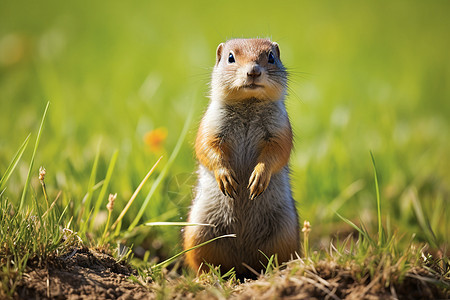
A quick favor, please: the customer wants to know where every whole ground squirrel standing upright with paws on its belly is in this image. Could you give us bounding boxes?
[184,39,299,277]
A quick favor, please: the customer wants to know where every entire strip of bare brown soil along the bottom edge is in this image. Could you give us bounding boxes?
[15,249,450,299]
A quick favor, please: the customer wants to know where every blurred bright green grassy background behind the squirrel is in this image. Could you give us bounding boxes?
[0,1,450,256]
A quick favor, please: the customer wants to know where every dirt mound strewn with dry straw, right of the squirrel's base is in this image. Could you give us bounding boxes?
[236,261,450,300]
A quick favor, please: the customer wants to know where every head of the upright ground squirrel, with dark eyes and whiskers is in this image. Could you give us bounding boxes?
[211,39,287,103]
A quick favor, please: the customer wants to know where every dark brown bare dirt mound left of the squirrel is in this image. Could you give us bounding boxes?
[16,249,153,299]
